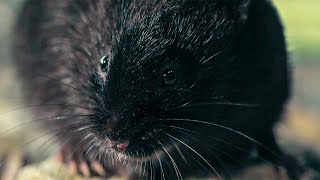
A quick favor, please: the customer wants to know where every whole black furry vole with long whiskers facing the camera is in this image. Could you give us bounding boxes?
[15,0,297,179]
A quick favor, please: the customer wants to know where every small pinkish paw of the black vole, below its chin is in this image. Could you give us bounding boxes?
[58,148,113,177]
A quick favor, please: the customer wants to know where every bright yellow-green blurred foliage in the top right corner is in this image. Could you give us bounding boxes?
[273,0,320,57]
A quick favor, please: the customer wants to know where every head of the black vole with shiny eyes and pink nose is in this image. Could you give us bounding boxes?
[85,0,252,156]
